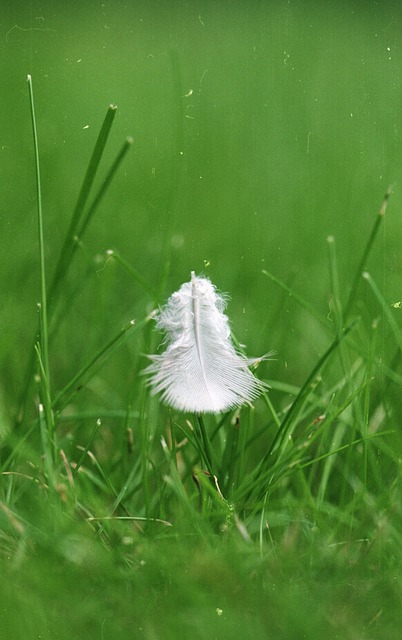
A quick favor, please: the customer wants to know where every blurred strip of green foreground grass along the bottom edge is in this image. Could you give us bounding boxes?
[1,503,401,640]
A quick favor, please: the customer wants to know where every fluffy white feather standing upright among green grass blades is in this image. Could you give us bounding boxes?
[144,272,267,413]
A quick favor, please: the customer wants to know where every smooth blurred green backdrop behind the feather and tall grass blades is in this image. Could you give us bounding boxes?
[0,0,402,400]
